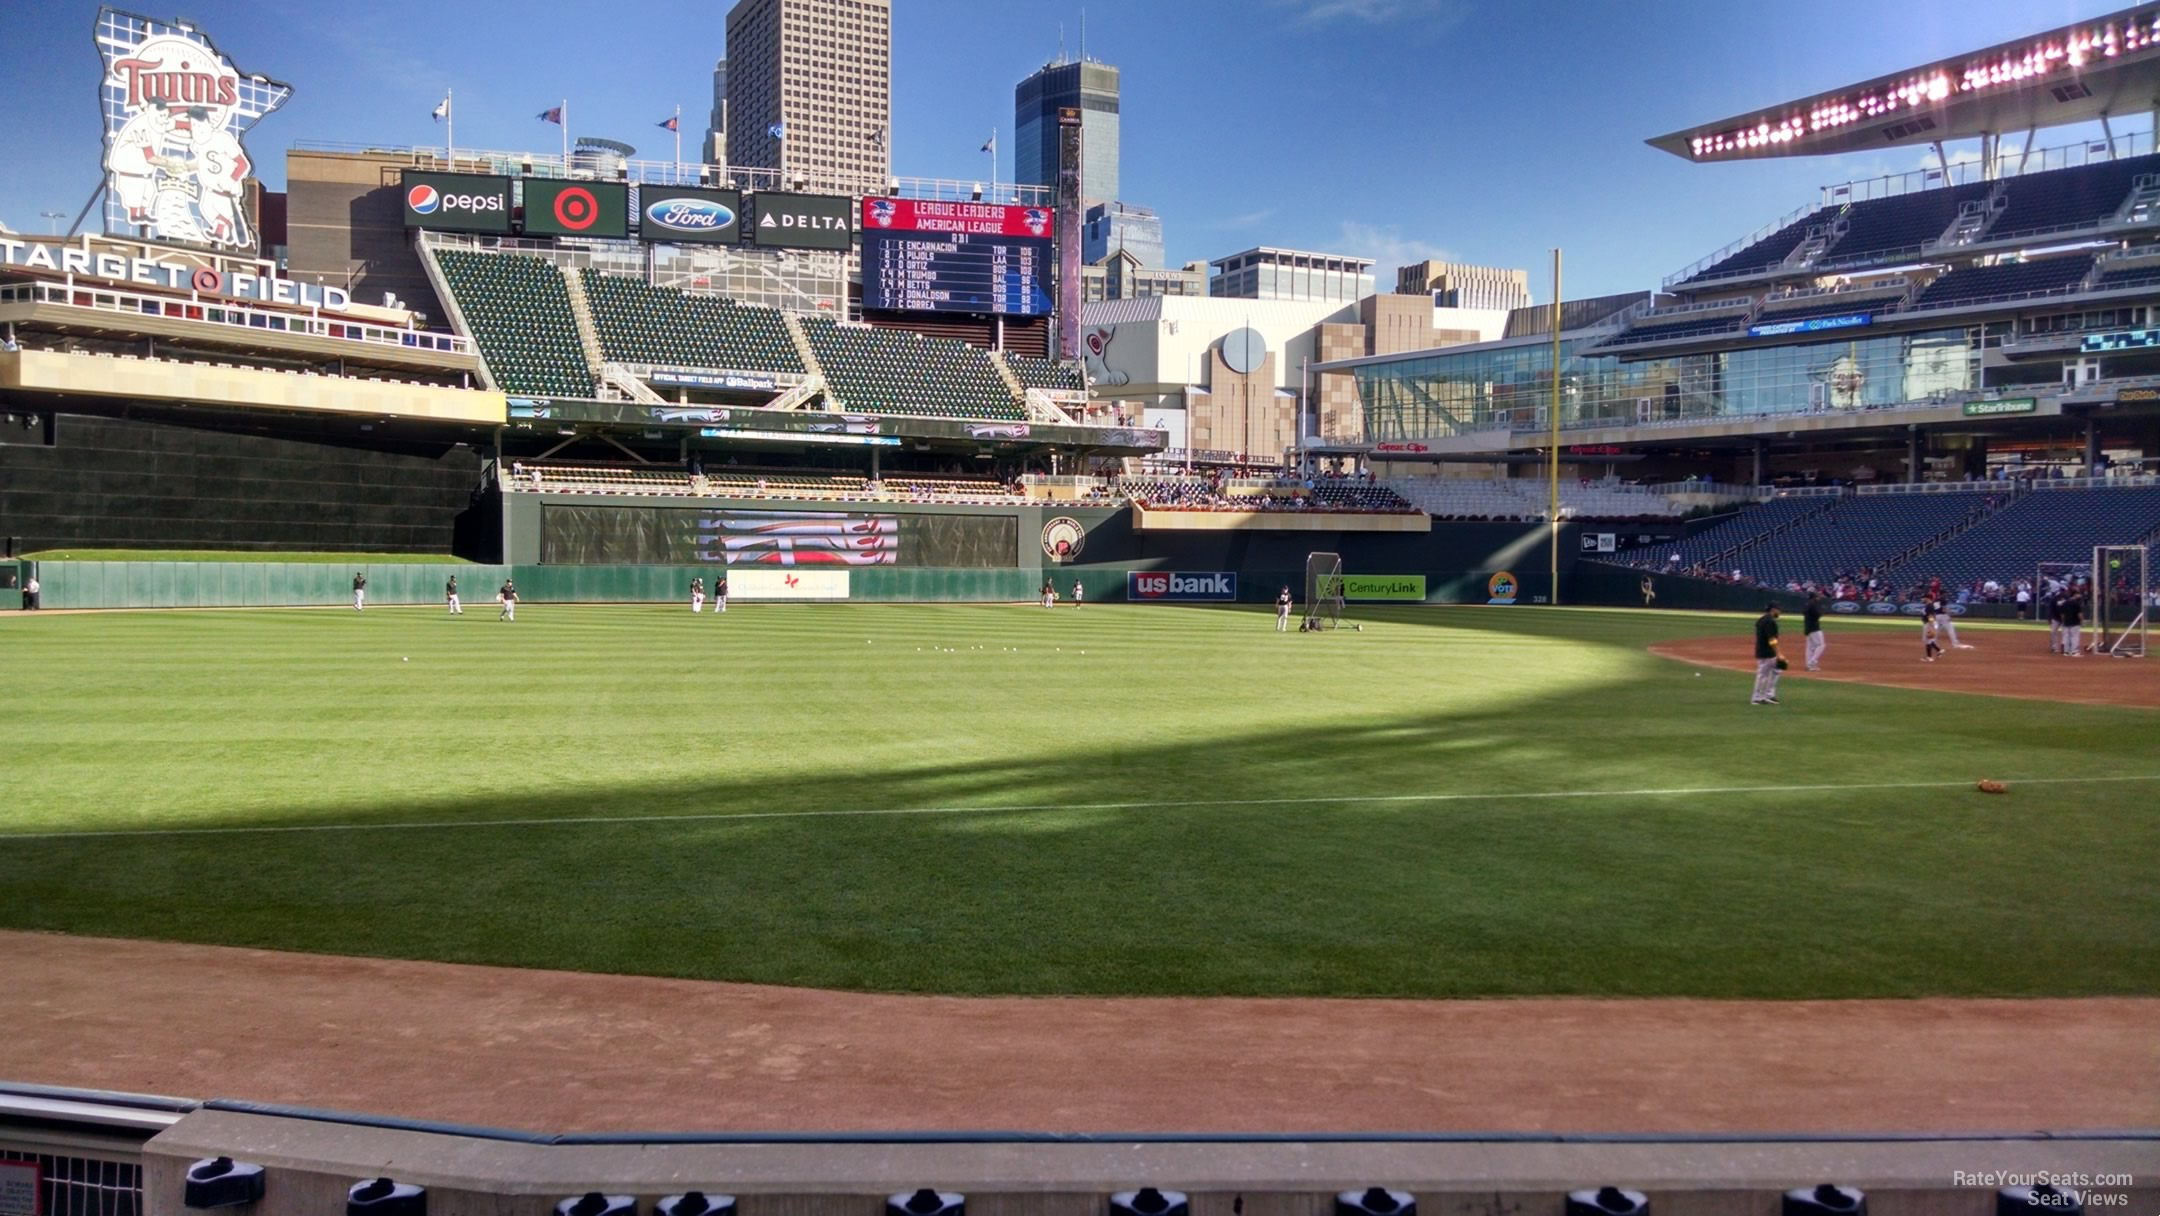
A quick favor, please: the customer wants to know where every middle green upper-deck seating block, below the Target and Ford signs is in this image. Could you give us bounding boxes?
[583,270,804,376]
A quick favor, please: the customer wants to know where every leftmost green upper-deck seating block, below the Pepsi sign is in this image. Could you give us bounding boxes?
[436,248,592,397]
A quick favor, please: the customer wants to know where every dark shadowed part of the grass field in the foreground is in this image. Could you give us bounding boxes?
[0,639,2160,998]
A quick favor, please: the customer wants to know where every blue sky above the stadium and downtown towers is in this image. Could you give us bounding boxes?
[0,0,2149,298]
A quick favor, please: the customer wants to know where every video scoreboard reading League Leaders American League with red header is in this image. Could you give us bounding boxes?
[862,199,1056,317]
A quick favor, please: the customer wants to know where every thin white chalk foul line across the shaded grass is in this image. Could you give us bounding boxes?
[0,773,2160,840]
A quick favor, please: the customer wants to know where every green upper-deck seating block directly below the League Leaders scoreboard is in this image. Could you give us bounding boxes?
[804,317,1028,421]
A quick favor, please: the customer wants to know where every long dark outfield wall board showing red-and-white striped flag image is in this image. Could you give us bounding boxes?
[540,503,1020,568]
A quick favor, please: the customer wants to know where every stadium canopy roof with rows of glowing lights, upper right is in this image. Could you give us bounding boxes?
[1648,2,2160,162]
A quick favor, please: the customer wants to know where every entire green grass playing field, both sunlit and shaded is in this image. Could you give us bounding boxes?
[0,603,2160,998]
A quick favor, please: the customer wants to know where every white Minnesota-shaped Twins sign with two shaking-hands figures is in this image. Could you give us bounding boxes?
[97,9,292,251]
